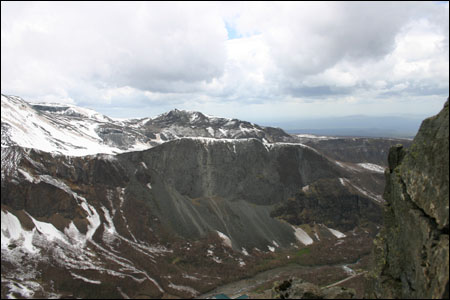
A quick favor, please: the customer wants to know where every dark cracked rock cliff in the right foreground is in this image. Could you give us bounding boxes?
[369,99,449,298]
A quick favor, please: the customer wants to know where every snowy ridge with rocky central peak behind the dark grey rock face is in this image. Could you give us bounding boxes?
[1,95,291,156]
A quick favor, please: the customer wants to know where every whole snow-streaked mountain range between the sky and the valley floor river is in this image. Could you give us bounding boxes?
[1,95,411,298]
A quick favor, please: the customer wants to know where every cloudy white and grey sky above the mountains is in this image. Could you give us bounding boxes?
[1,1,449,128]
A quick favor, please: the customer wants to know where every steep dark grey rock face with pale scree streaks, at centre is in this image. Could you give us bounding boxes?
[118,139,340,249]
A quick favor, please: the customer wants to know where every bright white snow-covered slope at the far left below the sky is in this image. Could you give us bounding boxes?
[1,95,150,156]
